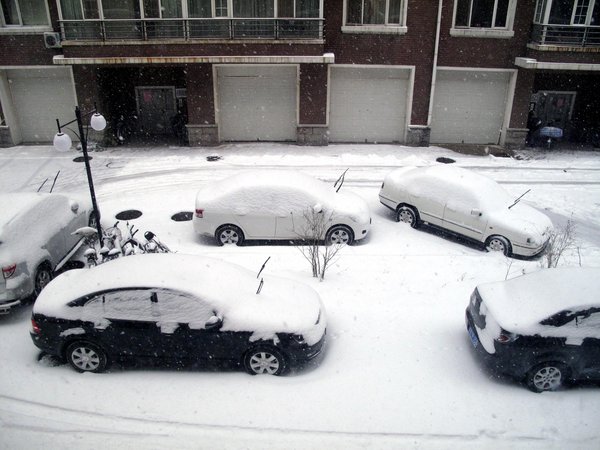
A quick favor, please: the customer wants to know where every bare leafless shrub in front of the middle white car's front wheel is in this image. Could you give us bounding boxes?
[297,207,344,281]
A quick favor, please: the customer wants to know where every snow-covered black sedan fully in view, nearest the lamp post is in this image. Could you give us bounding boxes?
[31,254,326,375]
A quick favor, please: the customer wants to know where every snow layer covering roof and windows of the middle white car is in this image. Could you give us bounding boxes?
[196,170,370,222]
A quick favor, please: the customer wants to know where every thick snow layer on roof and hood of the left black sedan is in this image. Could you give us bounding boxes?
[33,254,325,344]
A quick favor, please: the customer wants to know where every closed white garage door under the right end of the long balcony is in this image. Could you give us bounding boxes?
[217,66,297,141]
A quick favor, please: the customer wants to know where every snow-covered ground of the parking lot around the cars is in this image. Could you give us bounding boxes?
[0,144,600,449]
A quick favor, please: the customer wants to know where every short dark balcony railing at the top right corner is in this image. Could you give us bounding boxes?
[531,24,600,47]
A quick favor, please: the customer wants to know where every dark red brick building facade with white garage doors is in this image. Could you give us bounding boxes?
[0,0,600,147]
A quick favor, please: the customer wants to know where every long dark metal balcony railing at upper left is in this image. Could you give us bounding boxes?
[60,19,324,41]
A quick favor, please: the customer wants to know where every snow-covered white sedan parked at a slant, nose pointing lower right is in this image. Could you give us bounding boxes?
[379,165,553,256]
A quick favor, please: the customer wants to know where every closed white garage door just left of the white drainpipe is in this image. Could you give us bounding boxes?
[329,67,410,142]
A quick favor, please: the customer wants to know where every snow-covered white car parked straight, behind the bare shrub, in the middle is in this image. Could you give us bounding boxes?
[193,170,371,245]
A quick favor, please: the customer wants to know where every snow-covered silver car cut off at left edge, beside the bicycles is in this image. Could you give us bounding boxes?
[0,193,90,314]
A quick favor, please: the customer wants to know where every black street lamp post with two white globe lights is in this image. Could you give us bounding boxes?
[54,105,106,244]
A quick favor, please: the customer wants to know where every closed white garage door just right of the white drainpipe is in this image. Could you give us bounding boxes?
[431,70,510,144]
